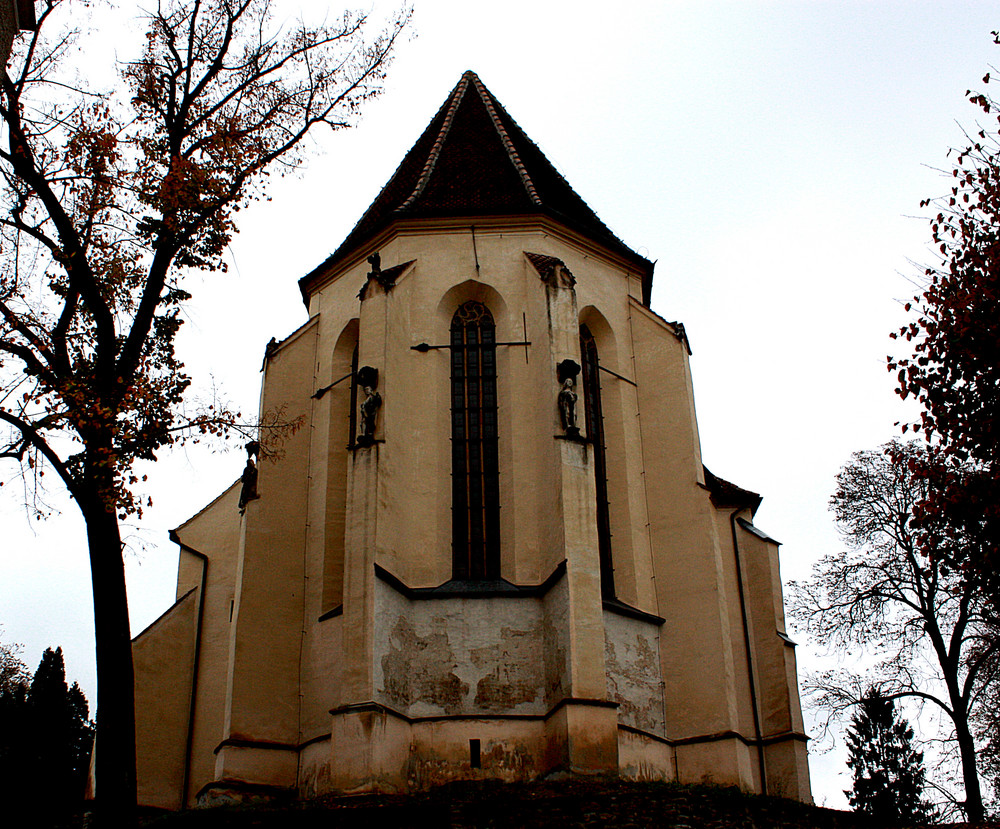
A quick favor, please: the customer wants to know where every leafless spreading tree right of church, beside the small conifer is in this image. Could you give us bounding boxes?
[790,442,1000,821]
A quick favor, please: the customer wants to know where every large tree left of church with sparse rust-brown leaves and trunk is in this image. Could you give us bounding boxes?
[0,0,409,823]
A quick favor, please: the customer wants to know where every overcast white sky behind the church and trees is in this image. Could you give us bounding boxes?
[0,0,1000,806]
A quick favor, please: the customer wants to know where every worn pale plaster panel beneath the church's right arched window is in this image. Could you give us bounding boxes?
[604,613,664,734]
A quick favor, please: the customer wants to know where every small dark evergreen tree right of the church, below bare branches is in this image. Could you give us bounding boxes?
[844,688,931,823]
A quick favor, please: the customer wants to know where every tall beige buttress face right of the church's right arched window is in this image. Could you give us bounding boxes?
[629,301,738,744]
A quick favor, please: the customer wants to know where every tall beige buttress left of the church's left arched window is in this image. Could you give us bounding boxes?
[215,322,316,785]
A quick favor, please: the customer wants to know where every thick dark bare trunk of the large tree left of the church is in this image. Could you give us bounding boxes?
[80,498,136,827]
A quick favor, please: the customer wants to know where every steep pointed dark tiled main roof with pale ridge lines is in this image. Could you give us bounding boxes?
[300,71,653,304]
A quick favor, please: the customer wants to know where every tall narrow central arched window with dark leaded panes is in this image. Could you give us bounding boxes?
[451,301,500,580]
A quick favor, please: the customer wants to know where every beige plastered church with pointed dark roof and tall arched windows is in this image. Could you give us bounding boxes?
[133,72,810,808]
